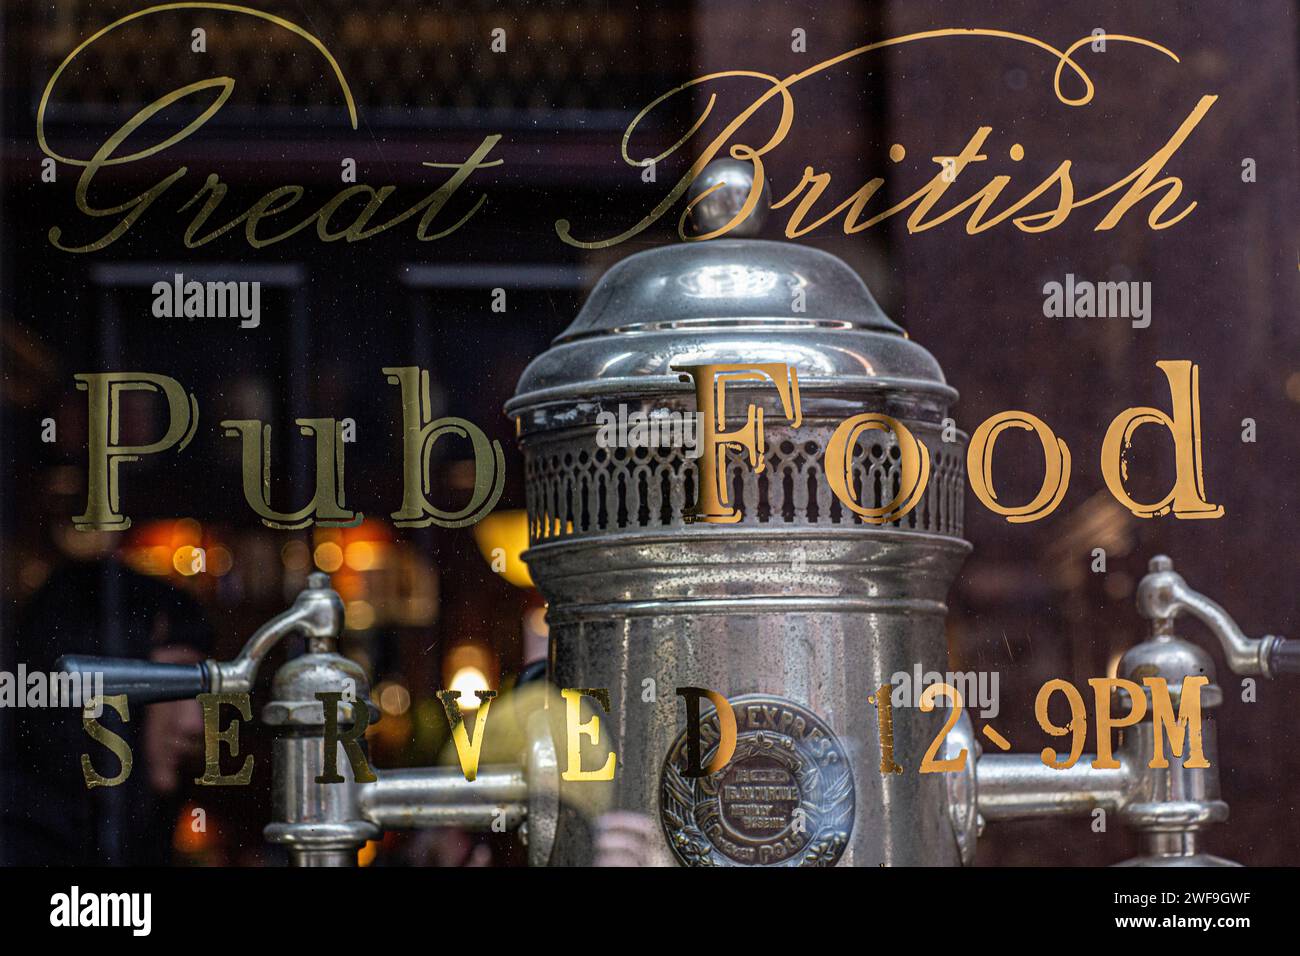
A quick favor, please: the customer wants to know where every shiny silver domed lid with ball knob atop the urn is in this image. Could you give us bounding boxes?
[506,161,956,414]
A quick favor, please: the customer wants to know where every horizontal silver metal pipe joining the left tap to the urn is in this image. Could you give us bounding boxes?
[358,763,528,830]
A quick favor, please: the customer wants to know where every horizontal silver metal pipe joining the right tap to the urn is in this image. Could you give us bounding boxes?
[975,753,1134,819]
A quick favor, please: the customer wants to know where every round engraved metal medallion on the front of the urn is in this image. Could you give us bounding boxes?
[659,695,853,866]
